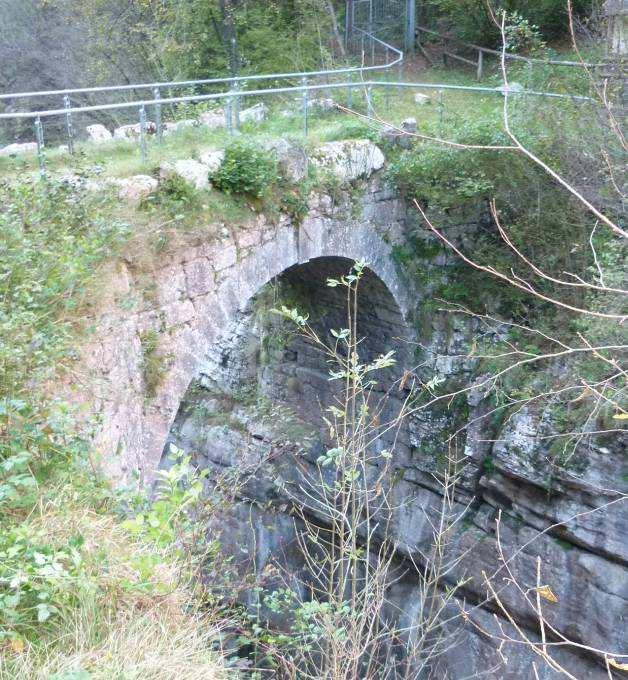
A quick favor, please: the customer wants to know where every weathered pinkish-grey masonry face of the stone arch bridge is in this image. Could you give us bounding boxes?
[85,177,413,481]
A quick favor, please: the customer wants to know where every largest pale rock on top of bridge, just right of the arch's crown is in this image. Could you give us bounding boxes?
[312,139,385,182]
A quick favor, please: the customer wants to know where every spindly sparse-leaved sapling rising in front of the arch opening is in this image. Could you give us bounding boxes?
[263,262,472,680]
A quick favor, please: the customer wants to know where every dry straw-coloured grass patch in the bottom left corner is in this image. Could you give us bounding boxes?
[0,497,232,680]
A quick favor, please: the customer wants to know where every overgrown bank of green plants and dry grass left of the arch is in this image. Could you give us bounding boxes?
[0,178,228,680]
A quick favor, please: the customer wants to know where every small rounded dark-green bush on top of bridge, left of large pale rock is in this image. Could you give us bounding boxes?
[211,140,278,198]
